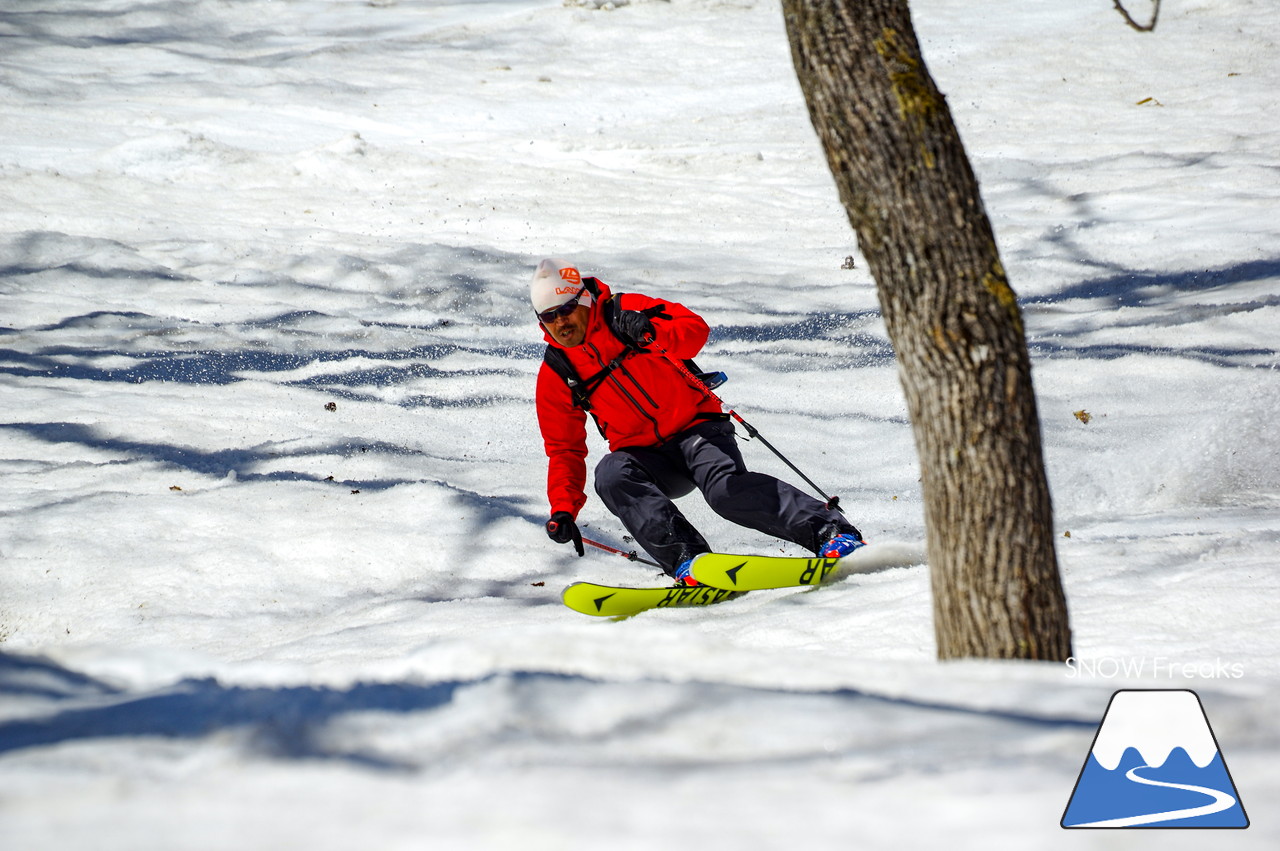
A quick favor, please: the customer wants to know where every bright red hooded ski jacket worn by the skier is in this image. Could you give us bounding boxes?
[536,279,723,517]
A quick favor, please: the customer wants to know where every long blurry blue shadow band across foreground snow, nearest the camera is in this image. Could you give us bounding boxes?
[0,653,1097,770]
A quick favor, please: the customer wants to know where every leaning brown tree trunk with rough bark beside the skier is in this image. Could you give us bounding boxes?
[782,0,1071,660]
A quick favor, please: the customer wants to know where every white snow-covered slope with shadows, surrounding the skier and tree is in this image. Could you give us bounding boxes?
[0,0,1280,851]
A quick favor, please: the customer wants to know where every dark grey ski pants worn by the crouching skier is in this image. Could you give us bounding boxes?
[595,421,858,573]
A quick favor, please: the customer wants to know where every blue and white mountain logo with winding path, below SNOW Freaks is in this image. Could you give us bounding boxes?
[1062,690,1249,828]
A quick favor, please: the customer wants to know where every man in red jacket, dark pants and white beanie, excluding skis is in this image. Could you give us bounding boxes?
[530,260,863,585]
